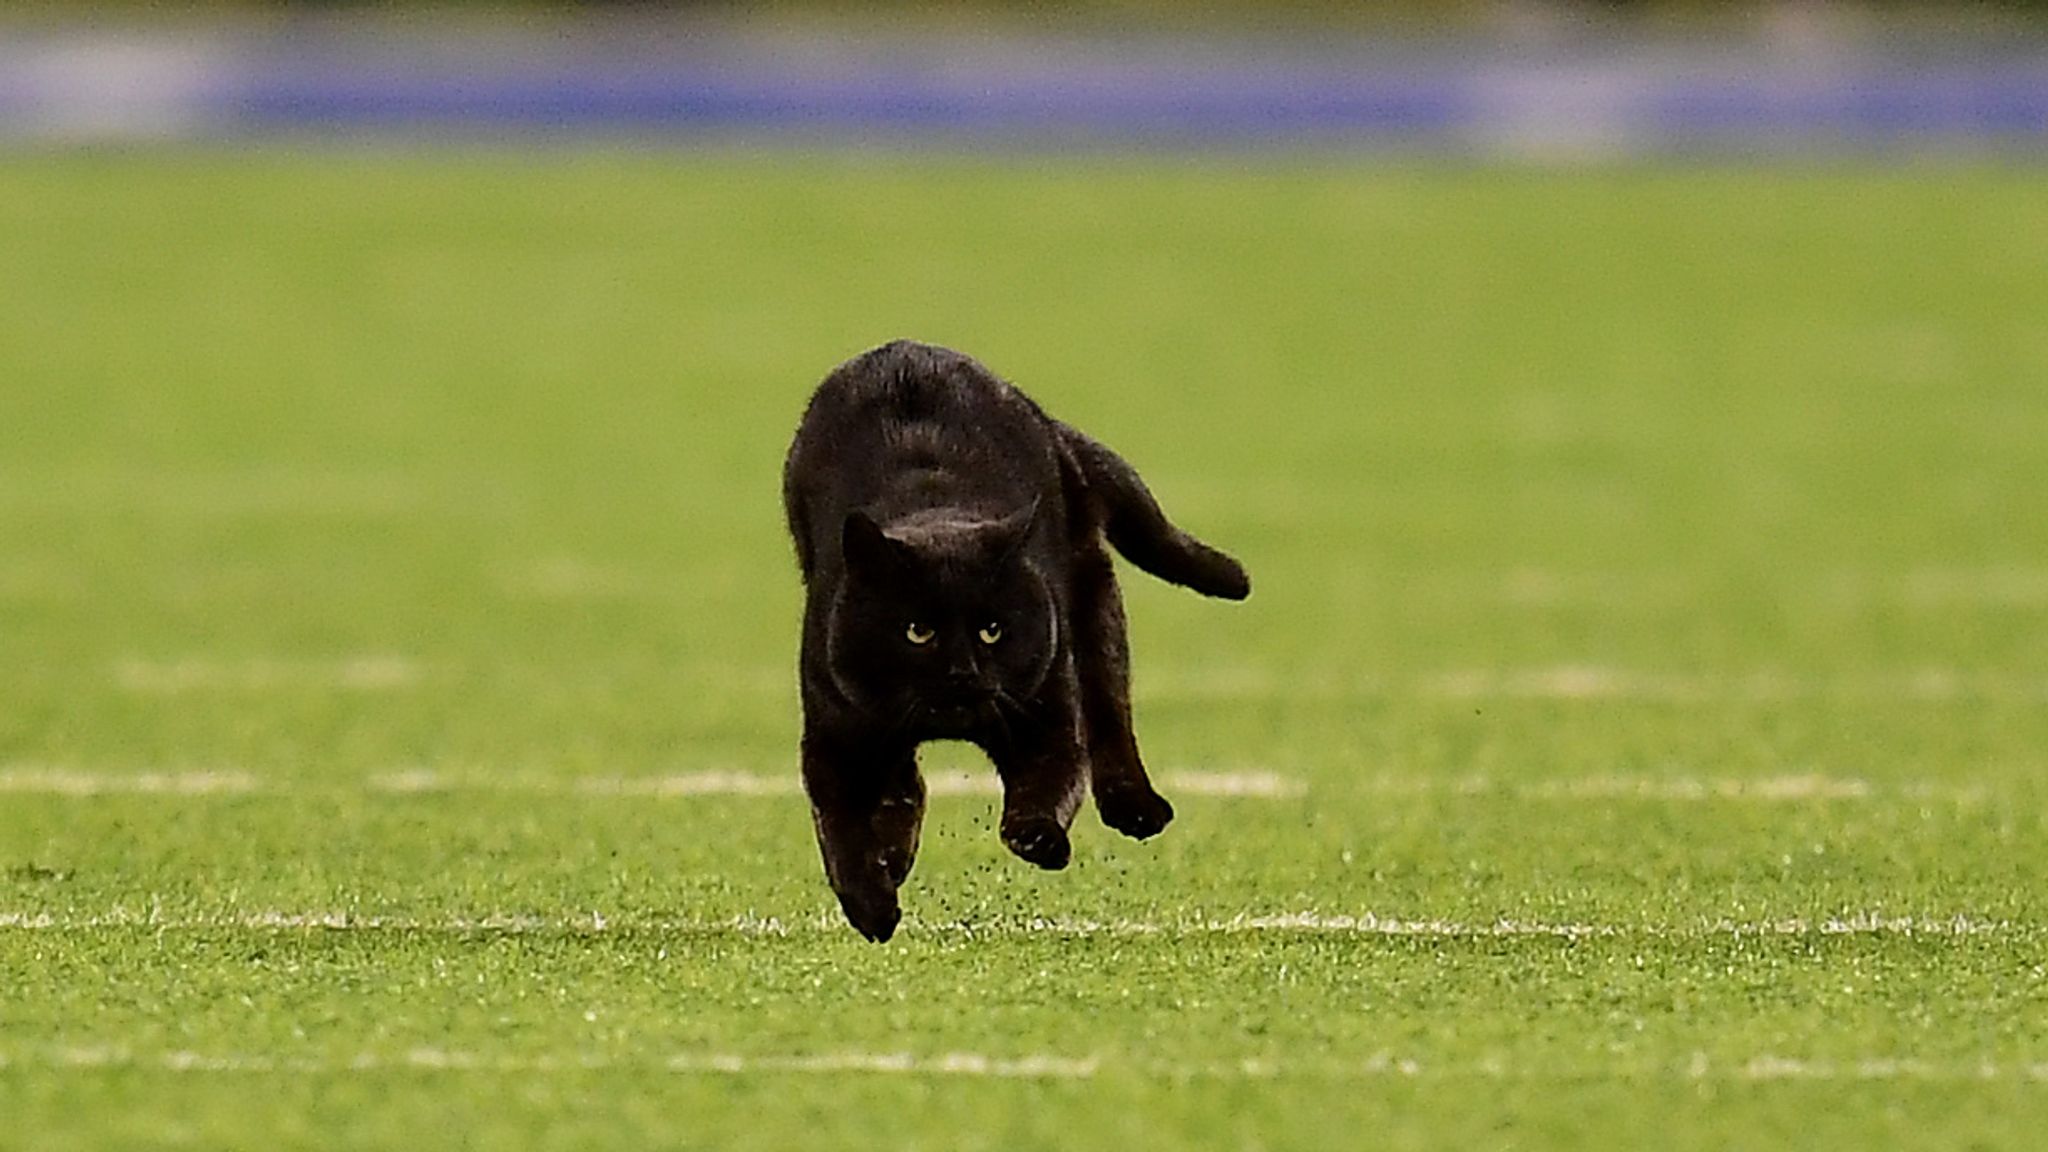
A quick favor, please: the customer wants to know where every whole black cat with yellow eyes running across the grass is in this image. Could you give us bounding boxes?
[782,340,1251,941]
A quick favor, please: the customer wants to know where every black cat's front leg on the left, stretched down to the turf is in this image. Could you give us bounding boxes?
[803,734,924,943]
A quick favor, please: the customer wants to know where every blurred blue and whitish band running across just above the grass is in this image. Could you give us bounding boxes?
[12,25,2048,152]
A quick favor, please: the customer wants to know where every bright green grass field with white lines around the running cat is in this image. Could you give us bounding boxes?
[0,152,2048,1150]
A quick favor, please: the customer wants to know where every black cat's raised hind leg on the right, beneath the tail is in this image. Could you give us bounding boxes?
[1073,543,1174,840]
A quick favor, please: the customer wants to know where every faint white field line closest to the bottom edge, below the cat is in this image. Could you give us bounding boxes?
[12,1045,2048,1084]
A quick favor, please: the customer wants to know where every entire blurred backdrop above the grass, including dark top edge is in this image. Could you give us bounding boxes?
[0,0,2048,158]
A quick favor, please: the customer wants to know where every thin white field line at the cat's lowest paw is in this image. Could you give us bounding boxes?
[0,908,2025,941]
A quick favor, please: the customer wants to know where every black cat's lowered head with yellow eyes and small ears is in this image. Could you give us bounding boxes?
[827,506,1059,738]
